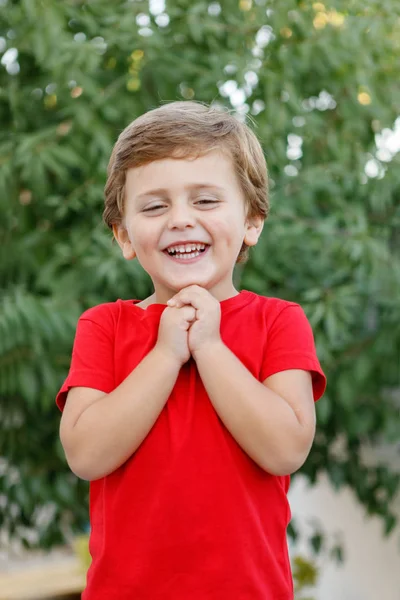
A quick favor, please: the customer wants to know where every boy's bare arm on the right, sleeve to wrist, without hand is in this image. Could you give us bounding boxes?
[196,341,315,475]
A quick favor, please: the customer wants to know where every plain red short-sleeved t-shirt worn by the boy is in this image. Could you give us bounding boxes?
[57,291,325,600]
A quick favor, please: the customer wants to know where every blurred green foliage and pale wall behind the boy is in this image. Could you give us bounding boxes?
[0,0,400,600]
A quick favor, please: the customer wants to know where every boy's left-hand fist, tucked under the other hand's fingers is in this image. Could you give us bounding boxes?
[156,306,196,366]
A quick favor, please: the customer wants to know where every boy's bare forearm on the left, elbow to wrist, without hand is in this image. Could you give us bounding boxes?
[69,347,180,480]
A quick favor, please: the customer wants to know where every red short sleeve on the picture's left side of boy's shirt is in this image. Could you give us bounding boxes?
[56,305,114,411]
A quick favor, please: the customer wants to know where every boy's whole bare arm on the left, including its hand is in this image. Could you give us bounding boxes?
[60,306,194,481]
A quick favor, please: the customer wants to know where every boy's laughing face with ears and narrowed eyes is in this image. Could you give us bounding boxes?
[114,151,263,303]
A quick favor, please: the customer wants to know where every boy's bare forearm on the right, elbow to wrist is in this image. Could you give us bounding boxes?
[196,342,308,475]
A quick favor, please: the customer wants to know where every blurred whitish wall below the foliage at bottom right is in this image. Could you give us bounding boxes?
[289,476,400,600]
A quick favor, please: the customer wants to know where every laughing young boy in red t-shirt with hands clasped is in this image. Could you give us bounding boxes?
[57,102,325,600]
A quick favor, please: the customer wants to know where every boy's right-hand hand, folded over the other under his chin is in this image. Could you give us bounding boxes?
[168,285,221,360]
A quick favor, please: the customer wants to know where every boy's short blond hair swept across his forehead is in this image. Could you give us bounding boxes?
[103,101,269,262]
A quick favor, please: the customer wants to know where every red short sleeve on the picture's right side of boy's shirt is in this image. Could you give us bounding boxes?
[261,304,326,401]
